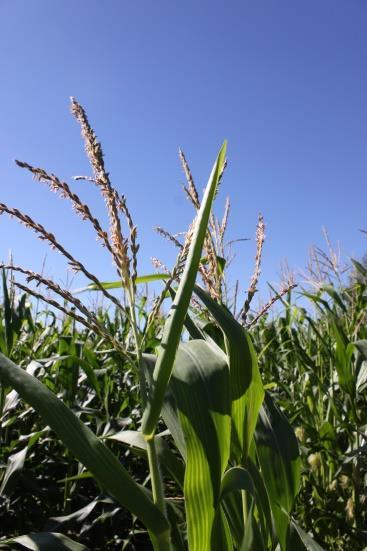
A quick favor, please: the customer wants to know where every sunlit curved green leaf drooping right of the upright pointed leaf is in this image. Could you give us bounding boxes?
[195,285,264,463]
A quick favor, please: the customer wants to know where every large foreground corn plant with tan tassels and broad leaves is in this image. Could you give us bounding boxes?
[0,99,320,551]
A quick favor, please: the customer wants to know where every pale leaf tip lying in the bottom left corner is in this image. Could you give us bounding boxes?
[0,532,89,551]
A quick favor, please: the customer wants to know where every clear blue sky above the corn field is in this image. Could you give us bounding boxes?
[0,0,367,304]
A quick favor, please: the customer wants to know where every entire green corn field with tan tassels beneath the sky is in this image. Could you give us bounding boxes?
[0,99,367,551]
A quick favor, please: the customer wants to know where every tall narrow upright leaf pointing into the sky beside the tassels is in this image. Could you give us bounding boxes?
[142,142,227,438]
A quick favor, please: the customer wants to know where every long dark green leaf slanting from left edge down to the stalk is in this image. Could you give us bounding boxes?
[0,354,168,536]
